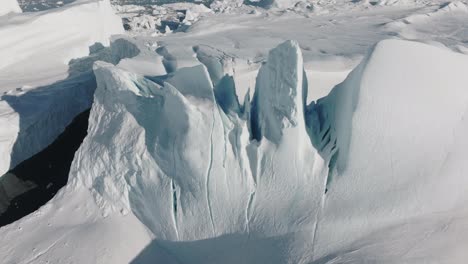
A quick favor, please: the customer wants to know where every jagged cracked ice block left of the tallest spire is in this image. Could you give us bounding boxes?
[71,60,253,240]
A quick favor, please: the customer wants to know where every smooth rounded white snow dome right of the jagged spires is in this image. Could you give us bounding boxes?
[315,40,468,263]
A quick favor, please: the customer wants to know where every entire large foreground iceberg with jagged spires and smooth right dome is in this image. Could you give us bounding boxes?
[0,40,468,264]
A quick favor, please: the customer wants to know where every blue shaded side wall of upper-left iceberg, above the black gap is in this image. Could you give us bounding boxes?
[0,39,140,174]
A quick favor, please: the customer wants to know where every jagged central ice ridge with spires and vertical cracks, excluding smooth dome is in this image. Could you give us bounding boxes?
[71,41,327,246]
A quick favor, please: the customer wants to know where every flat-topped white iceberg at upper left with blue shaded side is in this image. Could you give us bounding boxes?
[0,0,125,175]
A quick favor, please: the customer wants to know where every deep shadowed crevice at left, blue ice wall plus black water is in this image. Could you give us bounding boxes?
[0,39,140,225]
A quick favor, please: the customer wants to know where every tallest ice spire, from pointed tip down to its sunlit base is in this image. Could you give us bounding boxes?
[250,41,326,236]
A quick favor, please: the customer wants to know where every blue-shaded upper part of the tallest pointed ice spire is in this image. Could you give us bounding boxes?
[252,40,307,142]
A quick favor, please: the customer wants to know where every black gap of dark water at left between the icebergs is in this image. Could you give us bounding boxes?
[0,110,90,226]
